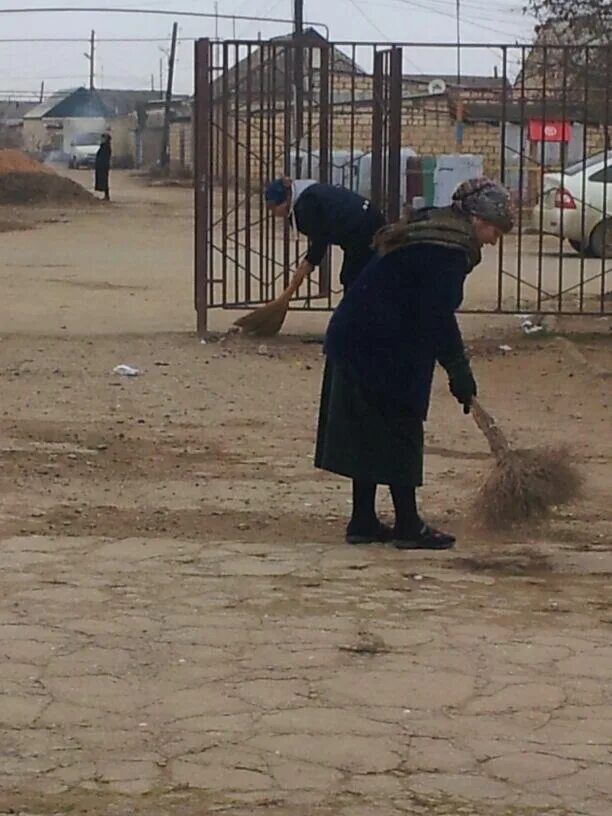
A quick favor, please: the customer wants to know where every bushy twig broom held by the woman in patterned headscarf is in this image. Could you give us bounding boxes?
[472,400,582,529]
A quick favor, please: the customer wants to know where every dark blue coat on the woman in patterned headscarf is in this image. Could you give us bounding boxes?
[325,244,468,419]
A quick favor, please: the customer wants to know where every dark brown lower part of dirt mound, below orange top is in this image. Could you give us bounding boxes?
[0,172,95,205]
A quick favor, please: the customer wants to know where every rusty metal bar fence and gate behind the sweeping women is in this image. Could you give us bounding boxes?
[194,35,612,331]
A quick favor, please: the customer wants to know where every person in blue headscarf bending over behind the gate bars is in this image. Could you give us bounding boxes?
[265,178,385,292]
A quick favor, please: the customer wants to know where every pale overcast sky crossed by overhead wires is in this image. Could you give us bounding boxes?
[0,0,533,98]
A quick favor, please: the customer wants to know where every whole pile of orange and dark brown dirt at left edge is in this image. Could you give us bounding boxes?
[0,150,95,205]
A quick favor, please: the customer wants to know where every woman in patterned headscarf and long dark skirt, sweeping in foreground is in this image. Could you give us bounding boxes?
[315,178,513,550]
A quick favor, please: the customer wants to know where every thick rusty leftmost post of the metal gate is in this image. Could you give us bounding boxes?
[194,40,211,337]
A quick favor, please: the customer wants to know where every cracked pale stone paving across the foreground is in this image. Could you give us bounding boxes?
[0,537,612,816]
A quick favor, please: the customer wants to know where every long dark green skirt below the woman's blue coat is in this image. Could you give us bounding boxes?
[315,362,423,487]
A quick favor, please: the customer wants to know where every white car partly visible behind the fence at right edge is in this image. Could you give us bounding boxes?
[533,151,612,258]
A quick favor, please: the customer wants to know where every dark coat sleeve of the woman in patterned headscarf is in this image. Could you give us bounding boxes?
[419,248,467,364]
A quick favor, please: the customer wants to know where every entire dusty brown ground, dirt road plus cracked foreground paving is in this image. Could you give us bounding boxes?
[0,169,612,816]
